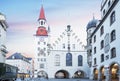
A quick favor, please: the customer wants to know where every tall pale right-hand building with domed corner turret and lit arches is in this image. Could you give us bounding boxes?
[87,0,120,81]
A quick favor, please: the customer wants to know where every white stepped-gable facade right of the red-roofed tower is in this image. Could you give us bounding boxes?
[47,25,89,78]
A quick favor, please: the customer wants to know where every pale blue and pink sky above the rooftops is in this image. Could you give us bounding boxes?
[0,0,101,57]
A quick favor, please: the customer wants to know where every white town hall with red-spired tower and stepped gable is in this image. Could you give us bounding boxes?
[34,6,89,78]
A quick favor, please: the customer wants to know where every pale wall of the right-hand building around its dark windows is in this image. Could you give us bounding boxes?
[87,0,120,79]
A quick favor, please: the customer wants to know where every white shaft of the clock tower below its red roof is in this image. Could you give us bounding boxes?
[34,36,48,77]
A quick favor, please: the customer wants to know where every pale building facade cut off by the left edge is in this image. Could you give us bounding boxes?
[0,13,8,63]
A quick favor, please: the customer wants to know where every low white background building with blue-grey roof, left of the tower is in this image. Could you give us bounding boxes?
[6,53,33,78]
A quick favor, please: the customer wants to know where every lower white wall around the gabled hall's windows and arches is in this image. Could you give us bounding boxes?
[47,50,89,78]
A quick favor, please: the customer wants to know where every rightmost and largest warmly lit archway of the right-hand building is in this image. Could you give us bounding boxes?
[110,63,119,81]
